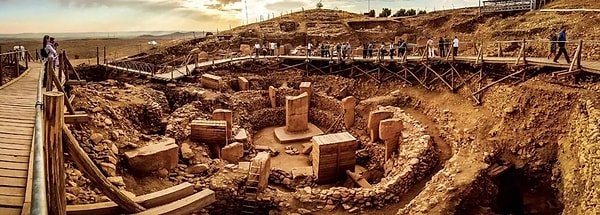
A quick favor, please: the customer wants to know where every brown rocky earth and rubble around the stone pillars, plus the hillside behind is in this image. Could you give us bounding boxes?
[62,0,600,214]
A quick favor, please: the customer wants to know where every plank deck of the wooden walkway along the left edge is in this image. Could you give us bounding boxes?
[0,63,41,215]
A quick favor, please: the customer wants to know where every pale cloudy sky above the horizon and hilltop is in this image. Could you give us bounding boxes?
[0,0,478,34]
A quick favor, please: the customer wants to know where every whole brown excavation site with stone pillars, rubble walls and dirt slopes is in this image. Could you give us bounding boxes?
[0,0,600,215]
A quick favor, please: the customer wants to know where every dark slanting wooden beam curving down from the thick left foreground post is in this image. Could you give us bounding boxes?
[62,124,146,213]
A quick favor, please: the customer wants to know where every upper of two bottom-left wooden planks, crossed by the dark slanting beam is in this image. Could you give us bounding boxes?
[67,182,194,215]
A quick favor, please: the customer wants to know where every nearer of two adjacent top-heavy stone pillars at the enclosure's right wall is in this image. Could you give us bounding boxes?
[379,119,404,161]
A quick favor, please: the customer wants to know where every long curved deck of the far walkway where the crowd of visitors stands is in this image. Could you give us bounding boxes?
[102,55,600,81]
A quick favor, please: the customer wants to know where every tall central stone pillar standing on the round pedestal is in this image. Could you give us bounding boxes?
[285,93,309,132]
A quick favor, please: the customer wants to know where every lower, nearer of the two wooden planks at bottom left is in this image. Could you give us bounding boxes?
[136,189,216,215]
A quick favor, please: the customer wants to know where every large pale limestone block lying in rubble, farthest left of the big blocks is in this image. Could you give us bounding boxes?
[125,138,179,173]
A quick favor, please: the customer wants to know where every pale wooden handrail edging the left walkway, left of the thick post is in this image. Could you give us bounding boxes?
[31,61,48,215]
